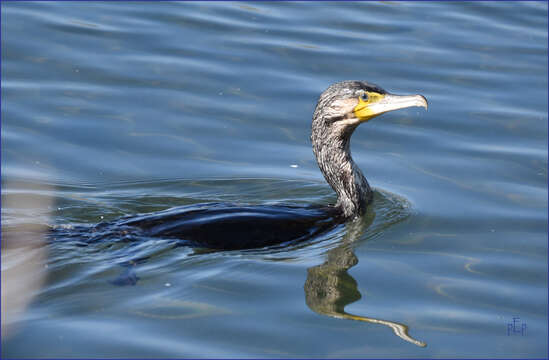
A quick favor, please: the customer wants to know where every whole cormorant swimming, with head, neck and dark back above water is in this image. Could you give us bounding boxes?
[57,81,427,250]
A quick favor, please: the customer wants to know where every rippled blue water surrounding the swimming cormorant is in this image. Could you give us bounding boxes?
[1,1,548,358]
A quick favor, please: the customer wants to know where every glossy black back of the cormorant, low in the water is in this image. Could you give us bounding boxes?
[118,203,340,250]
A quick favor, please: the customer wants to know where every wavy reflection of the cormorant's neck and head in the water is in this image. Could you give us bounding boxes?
[304,212,427,347]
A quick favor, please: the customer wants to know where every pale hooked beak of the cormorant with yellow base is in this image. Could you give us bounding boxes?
[354,94,428,122]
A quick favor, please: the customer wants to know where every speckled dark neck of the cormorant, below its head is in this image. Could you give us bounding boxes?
[312,125,373,218]
